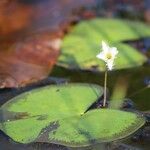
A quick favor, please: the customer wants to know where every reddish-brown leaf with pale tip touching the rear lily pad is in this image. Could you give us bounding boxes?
[0,34,61,88]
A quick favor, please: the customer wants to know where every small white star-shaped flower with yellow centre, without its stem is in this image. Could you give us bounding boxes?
[96,41,118,70]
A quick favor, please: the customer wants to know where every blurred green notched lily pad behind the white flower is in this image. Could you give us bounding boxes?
[57,19,150,71]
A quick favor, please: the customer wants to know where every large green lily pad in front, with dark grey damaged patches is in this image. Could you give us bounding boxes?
[0,84,145,147]
